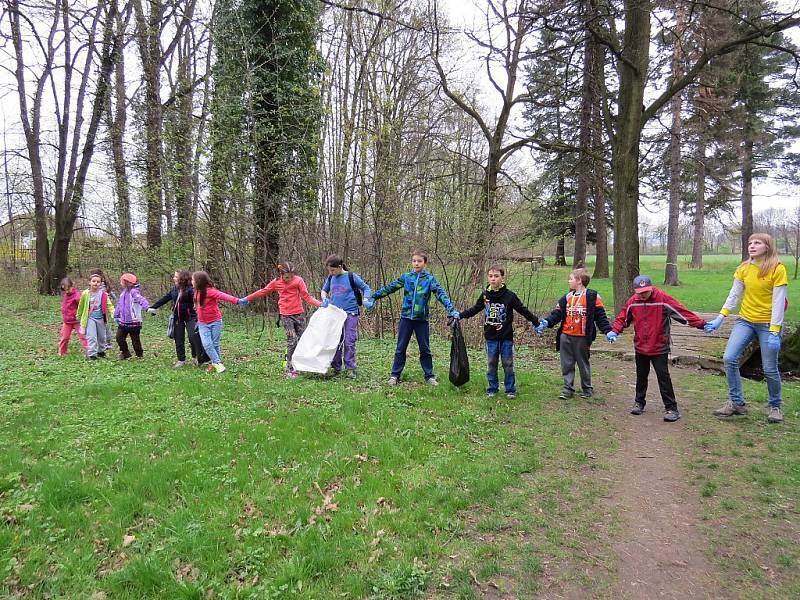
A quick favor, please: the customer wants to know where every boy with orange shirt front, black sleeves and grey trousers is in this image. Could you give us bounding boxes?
[536,269,611,400]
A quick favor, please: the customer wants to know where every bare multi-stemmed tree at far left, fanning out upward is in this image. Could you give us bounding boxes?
[6,0,117,293]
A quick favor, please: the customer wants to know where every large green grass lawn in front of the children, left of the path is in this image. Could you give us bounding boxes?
[0,294,615,599]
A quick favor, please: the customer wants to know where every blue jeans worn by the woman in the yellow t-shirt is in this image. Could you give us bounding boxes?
[722,317,781,407]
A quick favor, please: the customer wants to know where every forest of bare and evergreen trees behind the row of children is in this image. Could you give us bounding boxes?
[0,0,800,323]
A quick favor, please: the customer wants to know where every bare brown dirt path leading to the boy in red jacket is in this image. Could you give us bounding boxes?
[593,361,724,600]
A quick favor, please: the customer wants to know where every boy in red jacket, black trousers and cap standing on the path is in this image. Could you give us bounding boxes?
[606,275,706,422]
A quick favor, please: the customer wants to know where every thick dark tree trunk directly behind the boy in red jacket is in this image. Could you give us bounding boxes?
[611,0,651,310]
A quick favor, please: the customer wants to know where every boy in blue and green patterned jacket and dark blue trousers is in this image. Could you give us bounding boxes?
[364,250,458,385]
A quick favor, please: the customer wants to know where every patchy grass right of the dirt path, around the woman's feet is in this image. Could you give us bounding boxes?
[676,373,800,600]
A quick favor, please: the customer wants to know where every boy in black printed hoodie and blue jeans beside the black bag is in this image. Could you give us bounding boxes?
[458,265,539,399]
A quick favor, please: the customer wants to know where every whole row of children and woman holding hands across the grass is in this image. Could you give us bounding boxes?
[58,234,788,423]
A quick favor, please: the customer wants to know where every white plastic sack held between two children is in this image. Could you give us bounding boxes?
[292,304,347,373]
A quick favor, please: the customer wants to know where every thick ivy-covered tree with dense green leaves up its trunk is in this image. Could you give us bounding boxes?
[209,0,322,285]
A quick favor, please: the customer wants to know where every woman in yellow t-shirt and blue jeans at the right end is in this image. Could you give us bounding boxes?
[705,233,789,423]
